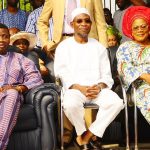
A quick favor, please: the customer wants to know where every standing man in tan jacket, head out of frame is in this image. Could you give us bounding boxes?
[37,0,107,57]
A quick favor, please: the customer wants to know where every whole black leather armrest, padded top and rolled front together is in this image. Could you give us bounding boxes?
[25,83,60,150]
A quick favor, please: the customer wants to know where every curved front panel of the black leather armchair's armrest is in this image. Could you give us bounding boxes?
[34,87,58,150]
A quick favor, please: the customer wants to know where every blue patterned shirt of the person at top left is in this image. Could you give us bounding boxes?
[0,9,27,31]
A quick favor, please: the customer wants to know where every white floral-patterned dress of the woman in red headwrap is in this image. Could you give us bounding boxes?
[117,41,150,124]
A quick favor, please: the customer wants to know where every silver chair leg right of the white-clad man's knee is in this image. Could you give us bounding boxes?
[122,88,130,150]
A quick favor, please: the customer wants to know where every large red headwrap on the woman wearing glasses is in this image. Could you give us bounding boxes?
[122,6,150,39]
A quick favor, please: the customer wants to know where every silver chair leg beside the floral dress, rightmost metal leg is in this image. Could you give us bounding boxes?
[133,87,138,150]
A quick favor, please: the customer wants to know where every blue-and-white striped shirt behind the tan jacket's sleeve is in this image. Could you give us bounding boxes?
[25,6,53,46]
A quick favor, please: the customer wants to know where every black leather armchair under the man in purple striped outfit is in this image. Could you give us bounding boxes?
[7,83,59,150]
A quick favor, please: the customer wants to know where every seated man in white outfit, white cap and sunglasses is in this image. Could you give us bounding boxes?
[54,8,124,150]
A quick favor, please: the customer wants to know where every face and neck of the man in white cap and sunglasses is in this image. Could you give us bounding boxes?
[71,14,92,43]
